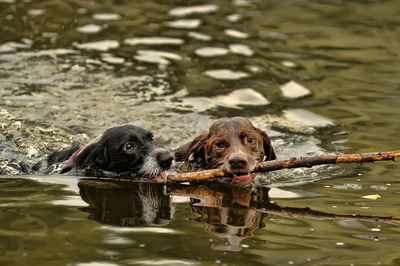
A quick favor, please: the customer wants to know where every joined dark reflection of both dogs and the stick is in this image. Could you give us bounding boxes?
[78,179,400,251]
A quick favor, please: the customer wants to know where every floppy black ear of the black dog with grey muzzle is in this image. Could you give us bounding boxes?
[73,143,108,169]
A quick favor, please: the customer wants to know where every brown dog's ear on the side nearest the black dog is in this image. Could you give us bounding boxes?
[173,134,208,161]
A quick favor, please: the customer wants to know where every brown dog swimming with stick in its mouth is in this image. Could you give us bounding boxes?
[175,117,276,174]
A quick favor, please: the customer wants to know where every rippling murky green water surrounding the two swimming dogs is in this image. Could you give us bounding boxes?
[0,0,400,265]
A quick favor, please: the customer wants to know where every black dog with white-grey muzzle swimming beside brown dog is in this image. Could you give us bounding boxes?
[33,125,173,179]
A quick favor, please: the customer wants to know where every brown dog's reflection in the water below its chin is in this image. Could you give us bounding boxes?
[168,183,269,251]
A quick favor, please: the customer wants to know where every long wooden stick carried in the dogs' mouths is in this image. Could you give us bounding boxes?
[167,150,400,183]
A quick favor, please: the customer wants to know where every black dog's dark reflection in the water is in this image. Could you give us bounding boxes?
[78,179,174,226]
